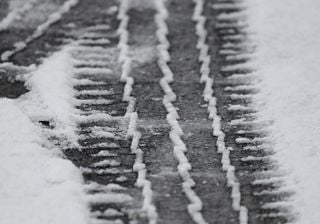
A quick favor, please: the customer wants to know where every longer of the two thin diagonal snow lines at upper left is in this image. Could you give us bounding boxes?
[1,0,79,61]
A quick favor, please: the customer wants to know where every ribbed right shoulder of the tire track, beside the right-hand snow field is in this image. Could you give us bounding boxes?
[205,0,291,223]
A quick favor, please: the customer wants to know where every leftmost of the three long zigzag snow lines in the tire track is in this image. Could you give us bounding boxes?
[118,0,158,224]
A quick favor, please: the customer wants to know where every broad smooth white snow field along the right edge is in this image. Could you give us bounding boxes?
[246,0,320,224]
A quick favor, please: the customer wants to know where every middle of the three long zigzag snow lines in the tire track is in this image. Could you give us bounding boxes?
[155,0,207,224]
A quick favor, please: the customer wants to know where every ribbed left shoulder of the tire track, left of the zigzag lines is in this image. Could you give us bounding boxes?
[65,23,142,224]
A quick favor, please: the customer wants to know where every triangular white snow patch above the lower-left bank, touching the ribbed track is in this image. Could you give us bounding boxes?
[21,47,77,145]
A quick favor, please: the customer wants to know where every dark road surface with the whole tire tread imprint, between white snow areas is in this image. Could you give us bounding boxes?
[0,0,290,224]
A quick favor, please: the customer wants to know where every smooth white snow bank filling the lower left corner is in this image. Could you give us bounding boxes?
[0,99,89,224]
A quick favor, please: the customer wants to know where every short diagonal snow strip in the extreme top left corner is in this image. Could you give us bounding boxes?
[0,0,38,31]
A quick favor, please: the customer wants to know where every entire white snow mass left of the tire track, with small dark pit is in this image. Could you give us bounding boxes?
[0,48,89,224]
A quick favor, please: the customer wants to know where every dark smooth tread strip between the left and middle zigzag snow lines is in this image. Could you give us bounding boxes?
[128,4,192,224]
